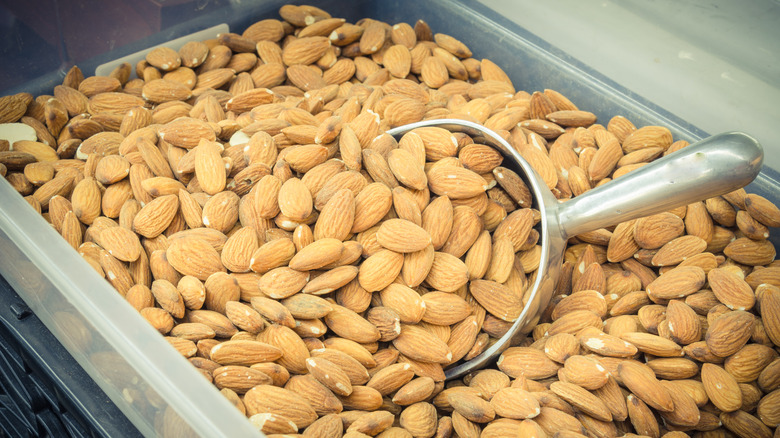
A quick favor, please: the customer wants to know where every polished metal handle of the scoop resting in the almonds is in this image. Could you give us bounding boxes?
[557,132,764,237]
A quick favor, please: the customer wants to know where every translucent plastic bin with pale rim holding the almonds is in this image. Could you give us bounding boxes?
[0,0,780,437]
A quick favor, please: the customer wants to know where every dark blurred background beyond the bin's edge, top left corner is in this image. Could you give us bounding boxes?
[0,0,229,94]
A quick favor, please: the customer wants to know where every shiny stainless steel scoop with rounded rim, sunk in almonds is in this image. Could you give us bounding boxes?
[387,119,764,379]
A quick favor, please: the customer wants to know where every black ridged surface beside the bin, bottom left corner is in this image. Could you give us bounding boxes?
[0,277,140,437]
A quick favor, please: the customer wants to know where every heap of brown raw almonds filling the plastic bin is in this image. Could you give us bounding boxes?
[0,5,780,437]
